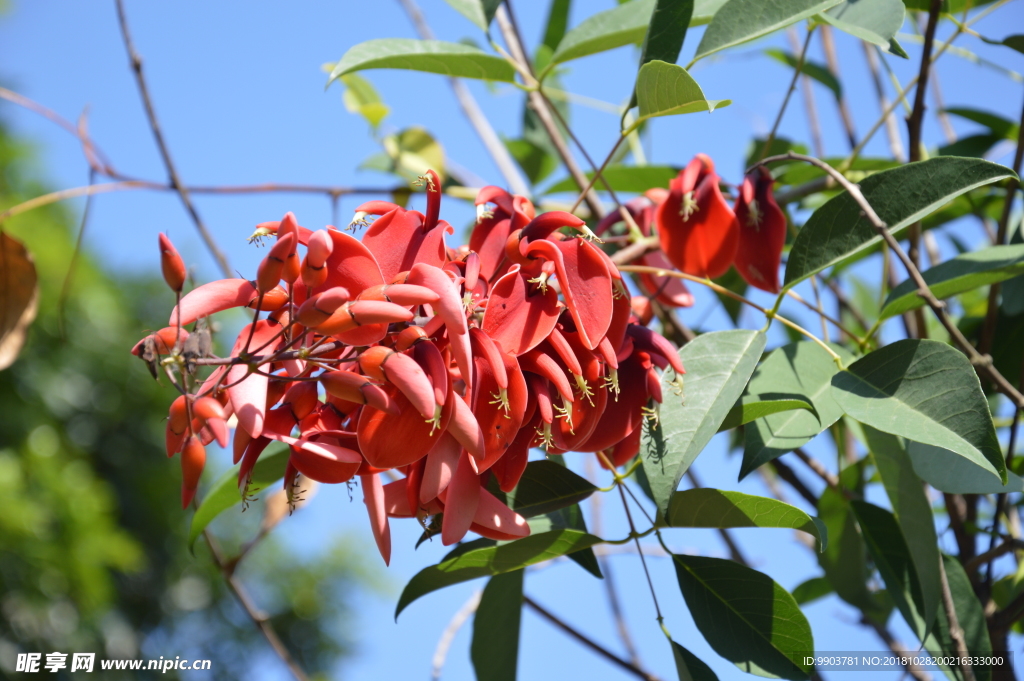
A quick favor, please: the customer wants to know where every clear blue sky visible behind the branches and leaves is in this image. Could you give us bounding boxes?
[0,0,1024,681]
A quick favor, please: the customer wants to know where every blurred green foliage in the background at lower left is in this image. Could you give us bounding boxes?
[0,125,380,679]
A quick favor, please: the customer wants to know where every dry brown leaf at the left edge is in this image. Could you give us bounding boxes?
[0,231,39,371]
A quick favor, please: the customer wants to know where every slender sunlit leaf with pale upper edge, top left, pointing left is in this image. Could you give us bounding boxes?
[328,38,515,85]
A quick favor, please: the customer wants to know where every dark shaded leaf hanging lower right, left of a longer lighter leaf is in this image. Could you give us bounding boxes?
[850,500,938,641]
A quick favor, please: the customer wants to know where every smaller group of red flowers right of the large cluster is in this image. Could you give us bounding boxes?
[597,154,785,299]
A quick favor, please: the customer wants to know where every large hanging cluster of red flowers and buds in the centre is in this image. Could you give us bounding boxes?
[134,171,679,562]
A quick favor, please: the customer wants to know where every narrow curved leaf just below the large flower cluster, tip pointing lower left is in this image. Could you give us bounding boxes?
[394,529,604,620]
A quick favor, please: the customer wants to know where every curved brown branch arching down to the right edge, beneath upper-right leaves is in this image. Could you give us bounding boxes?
[761,152,1024,407]
